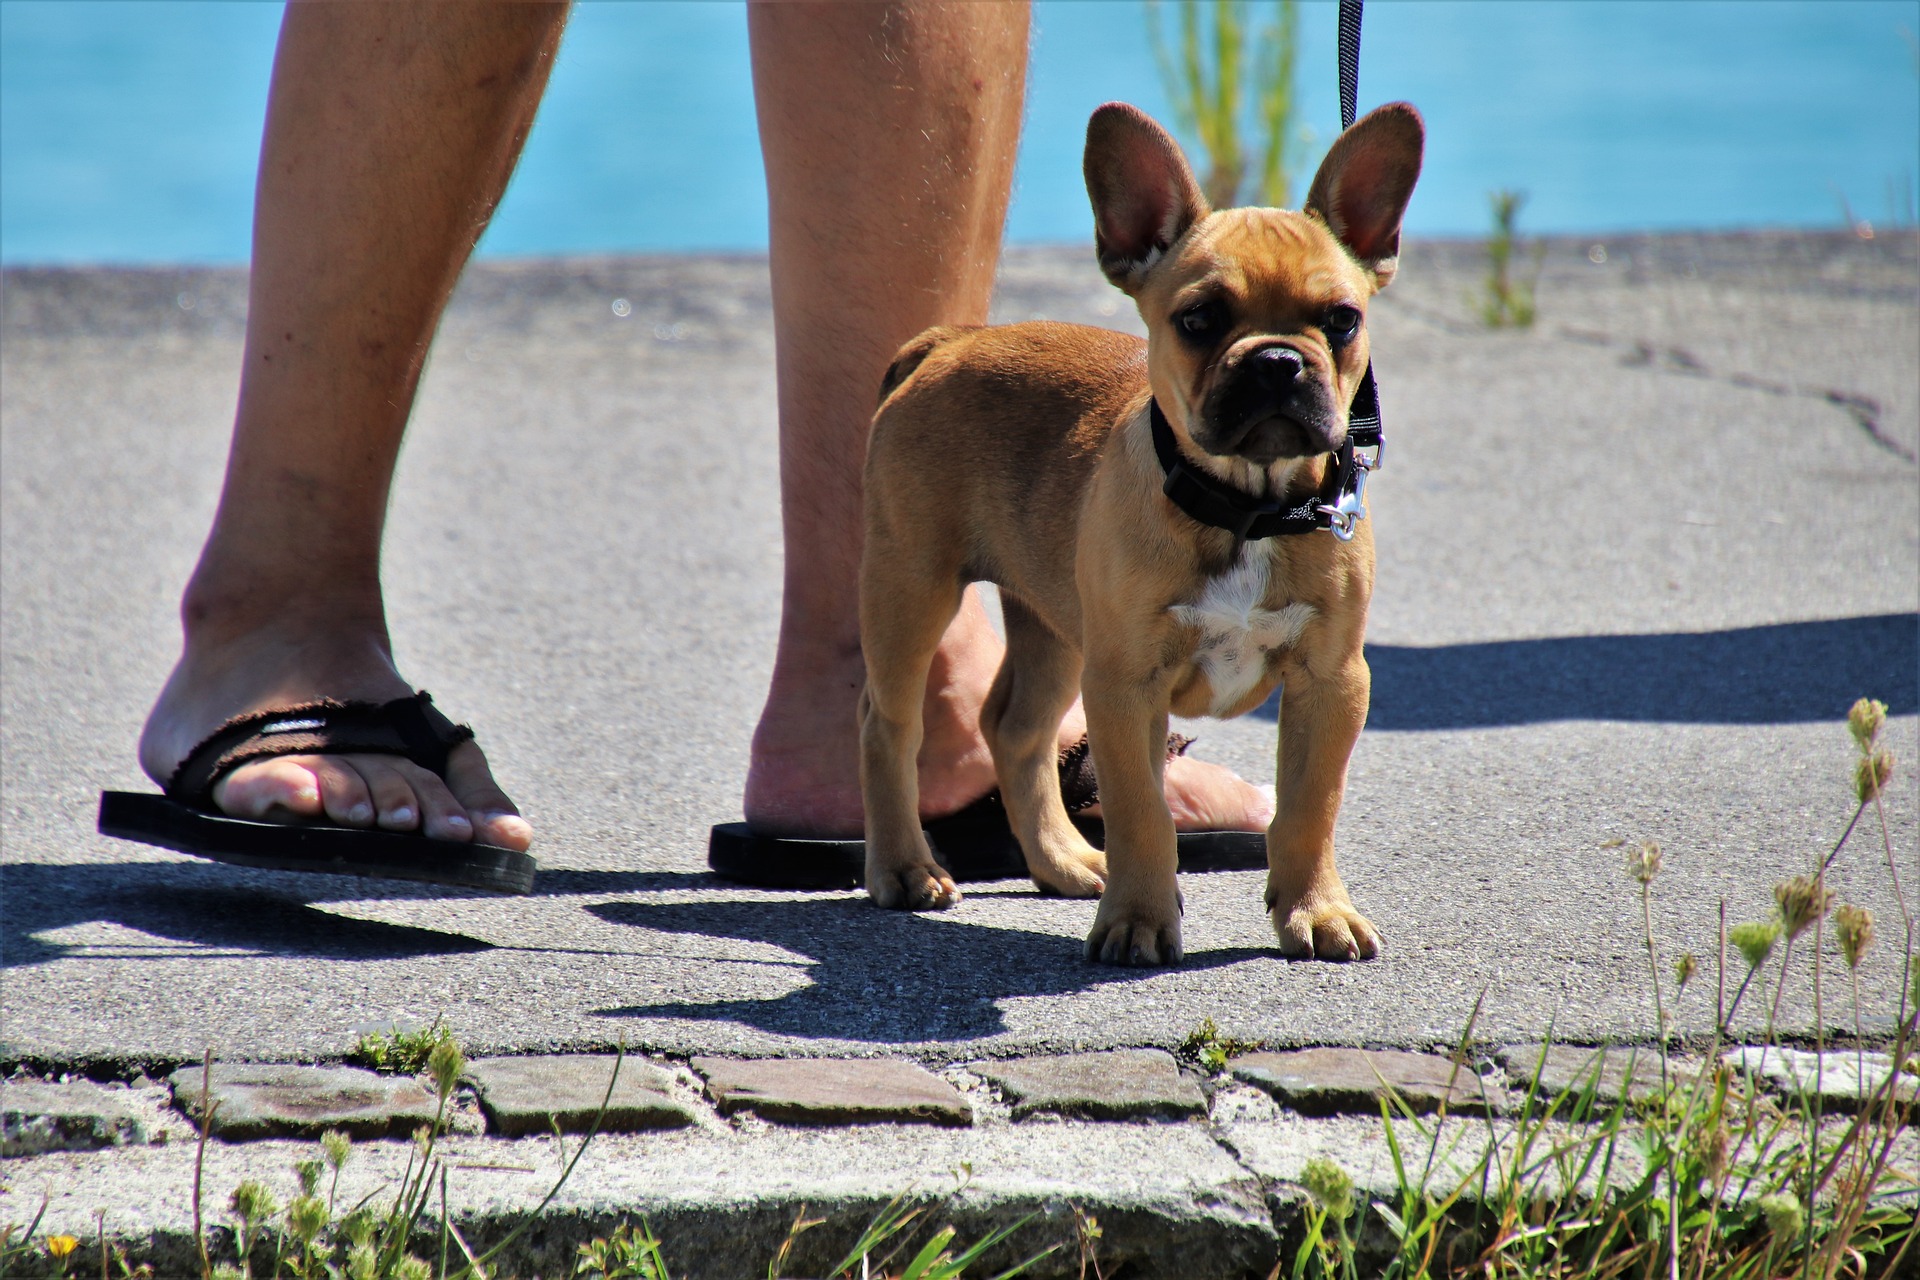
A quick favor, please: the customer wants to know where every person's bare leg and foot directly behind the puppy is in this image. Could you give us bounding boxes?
[745,0,1271,837]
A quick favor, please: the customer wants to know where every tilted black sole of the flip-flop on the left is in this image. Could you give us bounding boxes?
[100,791,538,894]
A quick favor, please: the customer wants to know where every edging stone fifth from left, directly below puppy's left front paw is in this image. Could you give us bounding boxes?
[970,1050,1206,1121]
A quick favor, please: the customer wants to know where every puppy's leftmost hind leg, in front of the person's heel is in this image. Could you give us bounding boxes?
[860,556,962,912]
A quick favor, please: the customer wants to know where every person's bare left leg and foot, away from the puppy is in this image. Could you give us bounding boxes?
[140,2,566,848]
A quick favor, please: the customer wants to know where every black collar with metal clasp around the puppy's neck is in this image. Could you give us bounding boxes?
[1148,365,1386,541]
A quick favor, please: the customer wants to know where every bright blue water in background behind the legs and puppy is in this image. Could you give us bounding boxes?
[0,0,1920,263]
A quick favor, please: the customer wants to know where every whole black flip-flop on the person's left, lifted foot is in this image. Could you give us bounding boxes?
[100,691,538,894]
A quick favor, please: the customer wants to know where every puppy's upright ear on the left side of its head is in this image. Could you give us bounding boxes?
[1087,102,1208,294]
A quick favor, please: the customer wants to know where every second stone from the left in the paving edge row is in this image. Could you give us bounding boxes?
[169,1063,436,1140]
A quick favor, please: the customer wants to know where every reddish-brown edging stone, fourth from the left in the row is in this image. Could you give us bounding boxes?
[693,1057,973,1125]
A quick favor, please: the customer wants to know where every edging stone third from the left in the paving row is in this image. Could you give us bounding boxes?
[467,1054,693,1138]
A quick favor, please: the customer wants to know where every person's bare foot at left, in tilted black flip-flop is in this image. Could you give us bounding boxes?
[140,620,534,850]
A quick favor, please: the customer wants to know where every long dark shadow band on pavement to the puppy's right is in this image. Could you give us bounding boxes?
[1282,614,1920,731]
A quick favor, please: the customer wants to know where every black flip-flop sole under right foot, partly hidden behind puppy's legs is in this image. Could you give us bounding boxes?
[707,810,1267,890]
